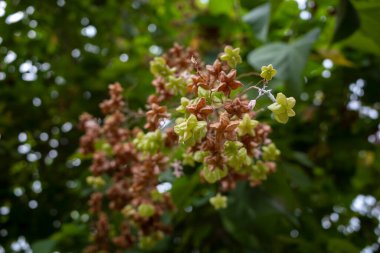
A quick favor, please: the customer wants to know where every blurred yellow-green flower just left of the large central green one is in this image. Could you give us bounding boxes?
[133,130,164,154]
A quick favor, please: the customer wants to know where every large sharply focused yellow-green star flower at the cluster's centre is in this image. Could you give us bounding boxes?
[174,114,207,146]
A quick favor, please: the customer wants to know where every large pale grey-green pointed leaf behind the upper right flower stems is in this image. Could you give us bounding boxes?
[248,28,320,94]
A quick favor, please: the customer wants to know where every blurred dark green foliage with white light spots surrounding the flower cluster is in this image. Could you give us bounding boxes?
[0,0,380,253]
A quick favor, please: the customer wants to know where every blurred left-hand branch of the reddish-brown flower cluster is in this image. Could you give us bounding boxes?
[80,83,173,252]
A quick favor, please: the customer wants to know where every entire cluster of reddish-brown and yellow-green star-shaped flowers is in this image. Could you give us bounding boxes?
[80,44,295,252]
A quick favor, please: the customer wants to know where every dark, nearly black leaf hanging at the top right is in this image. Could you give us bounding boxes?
[332,0,360,43]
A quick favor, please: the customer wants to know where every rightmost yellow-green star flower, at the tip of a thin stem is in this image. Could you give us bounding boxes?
[268,93,296,124]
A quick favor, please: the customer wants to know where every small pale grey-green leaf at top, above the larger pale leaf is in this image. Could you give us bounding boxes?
[243,3,271,41]
